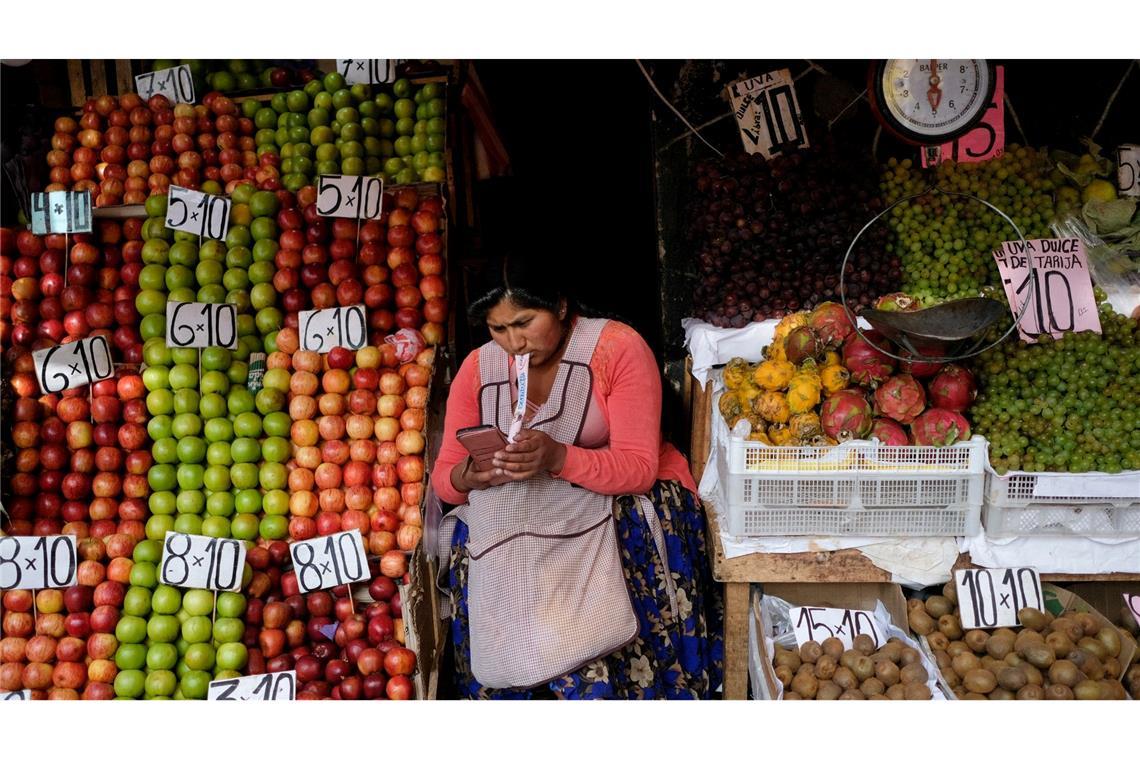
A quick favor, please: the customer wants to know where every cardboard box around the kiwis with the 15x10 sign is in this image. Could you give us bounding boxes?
[749,583,907,700]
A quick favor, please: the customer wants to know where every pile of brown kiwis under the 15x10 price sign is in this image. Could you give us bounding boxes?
[772,634,931,700]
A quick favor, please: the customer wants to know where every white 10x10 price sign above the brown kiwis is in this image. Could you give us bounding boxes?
[954,567,1045,630]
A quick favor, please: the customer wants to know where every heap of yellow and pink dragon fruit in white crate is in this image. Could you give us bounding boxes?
[718,302,976,447]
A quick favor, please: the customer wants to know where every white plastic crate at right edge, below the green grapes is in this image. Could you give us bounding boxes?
[984,466,1140,538]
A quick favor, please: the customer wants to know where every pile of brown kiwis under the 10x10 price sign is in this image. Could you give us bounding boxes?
[907,582,1137,700]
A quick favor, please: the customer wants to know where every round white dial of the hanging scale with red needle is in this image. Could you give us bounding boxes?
[871,58,994,145]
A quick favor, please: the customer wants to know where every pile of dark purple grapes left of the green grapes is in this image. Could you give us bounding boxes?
[686,138,901,327]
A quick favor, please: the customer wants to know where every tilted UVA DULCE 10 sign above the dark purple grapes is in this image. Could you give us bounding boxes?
[728,68,811,158]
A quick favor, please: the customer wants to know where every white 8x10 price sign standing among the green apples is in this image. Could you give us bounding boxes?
[158,531,245,591]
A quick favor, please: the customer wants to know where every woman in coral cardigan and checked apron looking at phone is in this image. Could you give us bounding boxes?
[432,256,723,698]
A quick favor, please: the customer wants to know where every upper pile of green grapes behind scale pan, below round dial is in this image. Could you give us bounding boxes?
[879,145,1053,305]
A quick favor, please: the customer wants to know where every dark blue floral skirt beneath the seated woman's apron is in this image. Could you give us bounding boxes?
[448,481,724,700]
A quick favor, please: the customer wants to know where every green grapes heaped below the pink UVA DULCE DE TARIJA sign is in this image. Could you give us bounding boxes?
[970,304,1140,473]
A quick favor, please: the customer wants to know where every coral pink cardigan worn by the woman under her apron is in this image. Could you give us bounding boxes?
[431,321,697,504]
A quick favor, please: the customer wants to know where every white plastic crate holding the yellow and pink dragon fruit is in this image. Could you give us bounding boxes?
[718,436,987,537]
